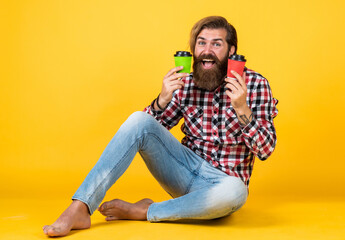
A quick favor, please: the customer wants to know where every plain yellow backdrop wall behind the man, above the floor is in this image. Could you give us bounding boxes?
[0,0,345,200]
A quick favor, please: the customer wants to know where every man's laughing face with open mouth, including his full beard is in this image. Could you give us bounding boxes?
[193,28,232,91]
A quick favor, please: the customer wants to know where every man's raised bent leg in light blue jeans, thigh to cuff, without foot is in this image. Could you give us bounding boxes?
[72,112,203,214]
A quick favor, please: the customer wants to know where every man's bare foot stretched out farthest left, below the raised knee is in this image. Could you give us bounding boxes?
[43,200,91,237]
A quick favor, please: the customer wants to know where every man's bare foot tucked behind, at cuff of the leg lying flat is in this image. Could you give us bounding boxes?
[98,198,153,221]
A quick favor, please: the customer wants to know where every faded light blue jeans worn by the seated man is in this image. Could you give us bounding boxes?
[72,112,248,222]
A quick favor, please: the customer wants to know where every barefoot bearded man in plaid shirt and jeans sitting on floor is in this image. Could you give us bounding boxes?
[43,16,277,236]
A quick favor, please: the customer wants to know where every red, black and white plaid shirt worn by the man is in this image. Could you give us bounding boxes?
[144,68,278,187]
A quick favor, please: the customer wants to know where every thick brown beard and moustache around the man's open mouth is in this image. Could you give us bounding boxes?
[193,54,228,91]
